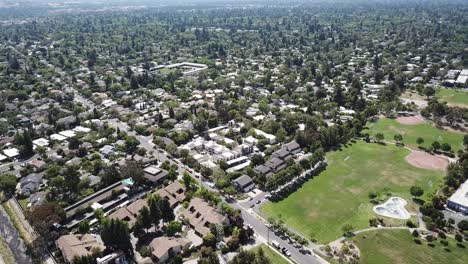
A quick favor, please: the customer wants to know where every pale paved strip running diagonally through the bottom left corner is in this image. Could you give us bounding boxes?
[0,206,33,264]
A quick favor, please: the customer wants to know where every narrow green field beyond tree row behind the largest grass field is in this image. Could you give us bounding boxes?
[363,118,463,151]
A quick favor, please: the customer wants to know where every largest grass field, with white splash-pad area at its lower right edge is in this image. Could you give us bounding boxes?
[261,141,444,242]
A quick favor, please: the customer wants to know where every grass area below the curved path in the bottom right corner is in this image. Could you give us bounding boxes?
[354,230,468,264]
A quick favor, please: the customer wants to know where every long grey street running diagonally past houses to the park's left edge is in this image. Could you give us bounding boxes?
[75,91,327,264]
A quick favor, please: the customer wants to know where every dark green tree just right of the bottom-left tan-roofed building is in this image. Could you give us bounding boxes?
[101,219,133,256]
